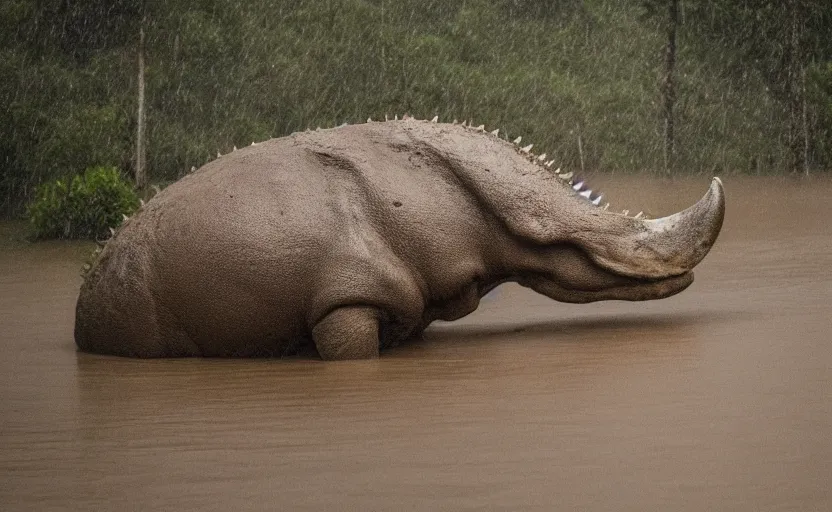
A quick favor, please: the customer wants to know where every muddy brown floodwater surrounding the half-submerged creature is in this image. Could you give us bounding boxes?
[0,176,832,511]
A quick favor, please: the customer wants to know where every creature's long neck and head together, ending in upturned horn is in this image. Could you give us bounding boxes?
[371,118,725,302]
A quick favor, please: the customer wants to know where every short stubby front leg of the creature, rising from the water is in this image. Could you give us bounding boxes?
[312,306,379,360]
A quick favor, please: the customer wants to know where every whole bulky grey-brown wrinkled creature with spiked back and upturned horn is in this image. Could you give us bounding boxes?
[75,119,725,359]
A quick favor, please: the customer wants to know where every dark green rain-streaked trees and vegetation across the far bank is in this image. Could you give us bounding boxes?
[0,0,832,215]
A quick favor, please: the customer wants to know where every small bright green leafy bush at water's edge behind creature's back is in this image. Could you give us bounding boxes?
[28,167,139,239]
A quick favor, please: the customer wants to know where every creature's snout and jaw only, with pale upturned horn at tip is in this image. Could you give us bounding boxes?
[518,178,725,303]
